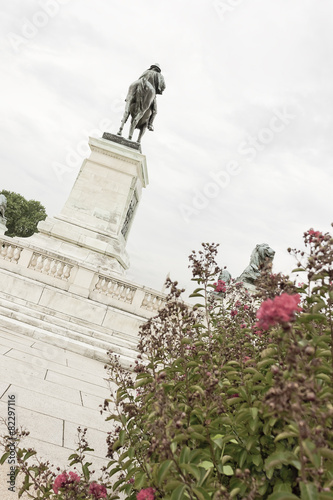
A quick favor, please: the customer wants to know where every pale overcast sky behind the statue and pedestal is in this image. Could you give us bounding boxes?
[0,0,333,291]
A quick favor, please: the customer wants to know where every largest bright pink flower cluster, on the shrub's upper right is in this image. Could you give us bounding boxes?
[256,293,302,330]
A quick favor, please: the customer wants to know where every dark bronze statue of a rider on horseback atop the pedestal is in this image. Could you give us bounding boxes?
[117,64,165,143]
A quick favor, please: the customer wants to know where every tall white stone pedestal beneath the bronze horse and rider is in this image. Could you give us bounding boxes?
[31,138,148,273]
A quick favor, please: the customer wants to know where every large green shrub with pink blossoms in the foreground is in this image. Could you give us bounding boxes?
[2,229,333,500]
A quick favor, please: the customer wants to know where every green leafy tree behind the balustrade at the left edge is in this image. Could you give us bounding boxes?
[0,190,47,237]
